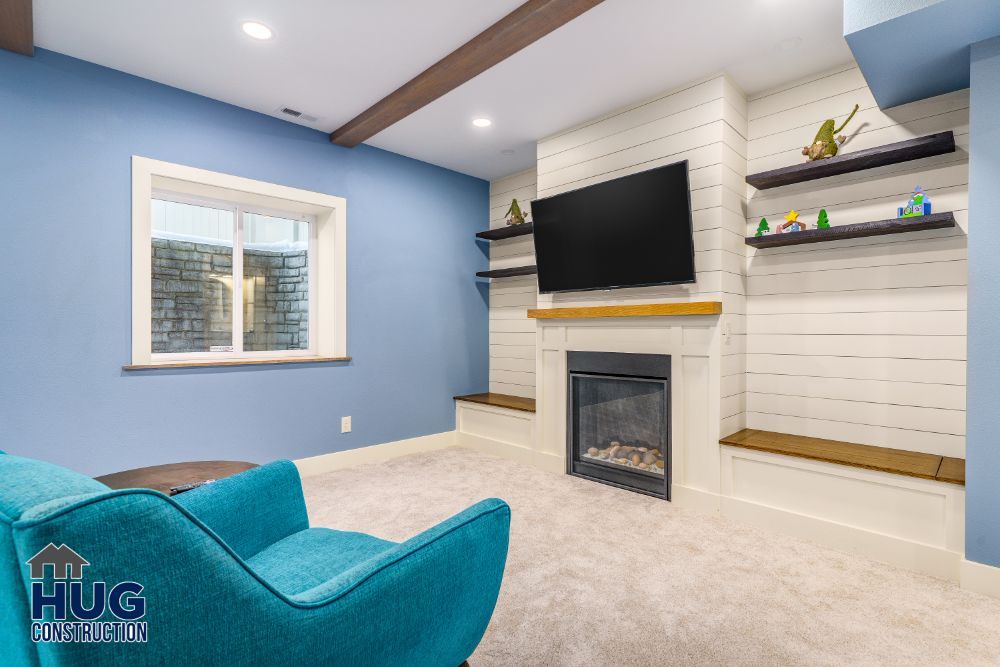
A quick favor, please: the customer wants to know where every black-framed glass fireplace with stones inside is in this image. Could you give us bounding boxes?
[566,352,670,500]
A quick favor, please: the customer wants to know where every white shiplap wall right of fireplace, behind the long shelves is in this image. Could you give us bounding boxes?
[746,64,969,457]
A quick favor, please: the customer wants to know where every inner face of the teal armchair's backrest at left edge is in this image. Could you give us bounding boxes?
[0,454,108,521]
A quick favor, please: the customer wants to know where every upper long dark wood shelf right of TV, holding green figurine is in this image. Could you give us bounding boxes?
[747,131,955,190]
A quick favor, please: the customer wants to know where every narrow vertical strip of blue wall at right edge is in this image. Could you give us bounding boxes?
[965,38,1000,567]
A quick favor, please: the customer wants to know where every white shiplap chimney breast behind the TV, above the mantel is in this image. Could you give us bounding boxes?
[538,75,747,435]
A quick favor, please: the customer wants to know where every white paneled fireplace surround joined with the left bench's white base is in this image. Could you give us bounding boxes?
[456,315,728,511]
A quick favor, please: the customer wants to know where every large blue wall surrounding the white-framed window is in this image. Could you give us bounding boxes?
[0,50,489,474]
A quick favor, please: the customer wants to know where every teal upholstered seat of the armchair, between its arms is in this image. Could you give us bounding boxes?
[247,528,396,595]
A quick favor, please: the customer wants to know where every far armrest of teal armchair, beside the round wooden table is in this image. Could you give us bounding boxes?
[173,461,309,559]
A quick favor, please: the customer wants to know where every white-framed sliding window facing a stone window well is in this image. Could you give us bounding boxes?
[131,157,347,367]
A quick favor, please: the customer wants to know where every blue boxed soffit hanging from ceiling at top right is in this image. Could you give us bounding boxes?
[844,0,1000,109]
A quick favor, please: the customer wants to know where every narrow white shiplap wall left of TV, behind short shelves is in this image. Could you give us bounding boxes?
[490,169,538,398]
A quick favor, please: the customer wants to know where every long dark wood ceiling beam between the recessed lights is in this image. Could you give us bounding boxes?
[330,0,603,147]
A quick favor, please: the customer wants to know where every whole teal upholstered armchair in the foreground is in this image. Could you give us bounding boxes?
[0,454,510,667]
